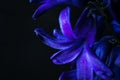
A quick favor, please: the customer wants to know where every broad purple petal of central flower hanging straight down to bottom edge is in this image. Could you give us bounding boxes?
[77,51,93,80]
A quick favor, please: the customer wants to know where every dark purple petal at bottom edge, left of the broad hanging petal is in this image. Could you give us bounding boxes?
[59,70,77,80]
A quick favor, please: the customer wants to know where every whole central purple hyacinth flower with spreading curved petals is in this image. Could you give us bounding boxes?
[35,7,112,80]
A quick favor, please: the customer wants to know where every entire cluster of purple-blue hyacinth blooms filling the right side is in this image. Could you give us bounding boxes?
[29,0,120,80]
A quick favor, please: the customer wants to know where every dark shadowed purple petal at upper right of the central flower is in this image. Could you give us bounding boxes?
[74,8,94,37]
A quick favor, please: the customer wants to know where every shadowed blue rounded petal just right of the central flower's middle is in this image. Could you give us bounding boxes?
[94,36,113,61]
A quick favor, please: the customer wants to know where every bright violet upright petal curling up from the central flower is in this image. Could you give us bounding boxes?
[59,7,75,39]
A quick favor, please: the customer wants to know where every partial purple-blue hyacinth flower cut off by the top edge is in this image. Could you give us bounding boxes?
[29,0,89,19]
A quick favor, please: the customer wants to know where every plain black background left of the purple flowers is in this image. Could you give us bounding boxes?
[0,0,79,80]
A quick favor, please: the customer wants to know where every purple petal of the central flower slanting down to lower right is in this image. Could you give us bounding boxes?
[86,47,112,80]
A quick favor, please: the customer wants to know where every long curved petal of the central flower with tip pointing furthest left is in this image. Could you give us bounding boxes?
[35,28,73,49]
